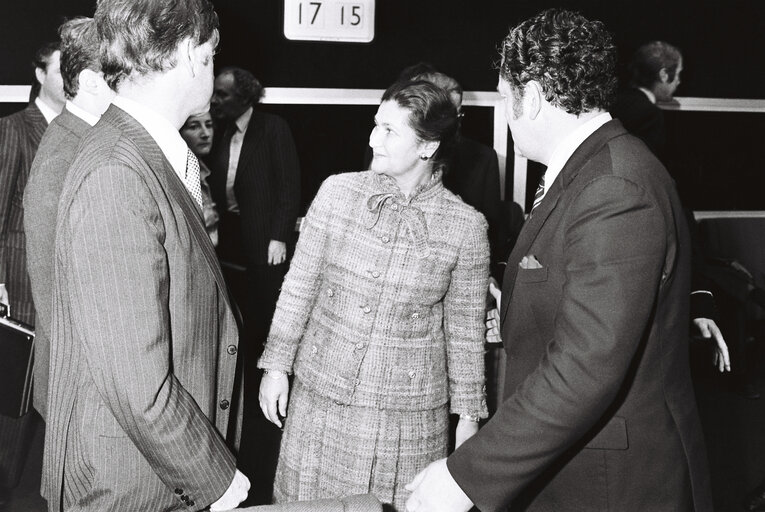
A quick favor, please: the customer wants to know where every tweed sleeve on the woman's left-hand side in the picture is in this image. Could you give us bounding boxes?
[258,177,336,372]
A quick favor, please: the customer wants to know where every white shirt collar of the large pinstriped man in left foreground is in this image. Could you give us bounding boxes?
[112,95,189,180]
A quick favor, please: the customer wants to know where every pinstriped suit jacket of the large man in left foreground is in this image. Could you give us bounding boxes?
[44,105,238,511]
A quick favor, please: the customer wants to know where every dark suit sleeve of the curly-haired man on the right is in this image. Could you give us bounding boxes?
[447,176,670,511]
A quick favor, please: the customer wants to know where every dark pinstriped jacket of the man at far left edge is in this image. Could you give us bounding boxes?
[0,102,48,325]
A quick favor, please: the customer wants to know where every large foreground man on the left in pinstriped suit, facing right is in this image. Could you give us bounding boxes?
[43,0,249,511]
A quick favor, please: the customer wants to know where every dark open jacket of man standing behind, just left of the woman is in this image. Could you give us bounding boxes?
[209,110,300,265]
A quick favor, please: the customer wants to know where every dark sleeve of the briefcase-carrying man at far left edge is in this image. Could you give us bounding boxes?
[0,118,21,288]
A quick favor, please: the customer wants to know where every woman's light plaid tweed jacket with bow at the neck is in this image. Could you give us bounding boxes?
[258,171,489,417]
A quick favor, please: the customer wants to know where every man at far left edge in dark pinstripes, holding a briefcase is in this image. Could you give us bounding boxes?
[0,43,64,504]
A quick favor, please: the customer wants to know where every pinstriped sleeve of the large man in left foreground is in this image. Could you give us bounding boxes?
[64,163,235,506]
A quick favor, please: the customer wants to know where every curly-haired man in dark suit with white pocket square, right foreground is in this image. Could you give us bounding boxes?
[407,9,712,511]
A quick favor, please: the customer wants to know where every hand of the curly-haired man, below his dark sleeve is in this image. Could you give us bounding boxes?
[406,459,473,512]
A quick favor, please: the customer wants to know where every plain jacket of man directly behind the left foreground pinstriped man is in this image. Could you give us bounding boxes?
[24,109,90,419]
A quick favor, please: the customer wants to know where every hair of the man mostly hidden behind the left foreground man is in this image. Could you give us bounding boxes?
[58,17,101,100]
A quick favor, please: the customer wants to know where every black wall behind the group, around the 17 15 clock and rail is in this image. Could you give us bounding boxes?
[0,0,765,209]
